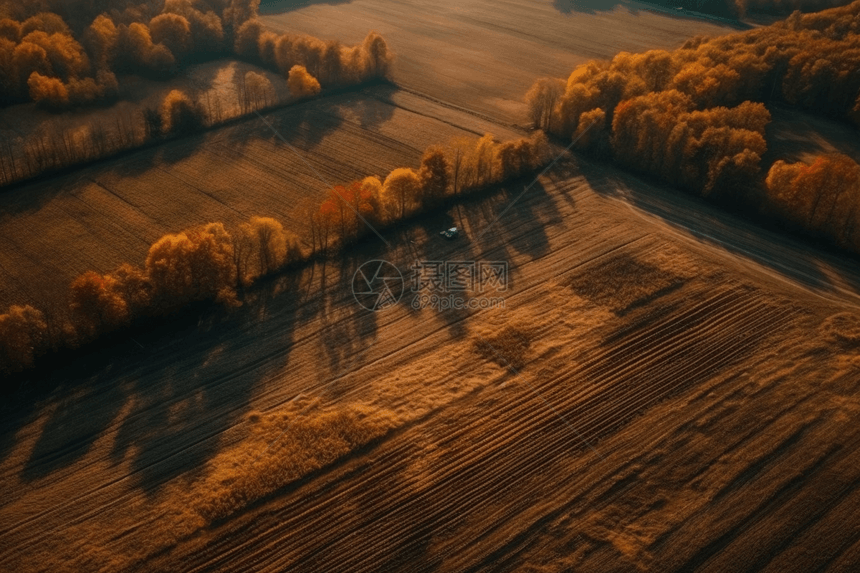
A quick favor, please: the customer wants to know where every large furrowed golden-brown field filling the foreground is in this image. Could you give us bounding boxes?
[0,150,860,572]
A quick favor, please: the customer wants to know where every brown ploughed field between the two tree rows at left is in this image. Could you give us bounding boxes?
[0,86,521,308]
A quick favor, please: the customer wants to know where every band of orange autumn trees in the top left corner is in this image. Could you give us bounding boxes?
[0,0,392,109]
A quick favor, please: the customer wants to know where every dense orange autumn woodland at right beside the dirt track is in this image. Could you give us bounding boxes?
[526,1,860,252]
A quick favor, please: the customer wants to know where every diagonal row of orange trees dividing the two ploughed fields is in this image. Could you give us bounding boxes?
[0,131,550,375]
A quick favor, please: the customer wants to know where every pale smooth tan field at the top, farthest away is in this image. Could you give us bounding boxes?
[260,0,742,124]
